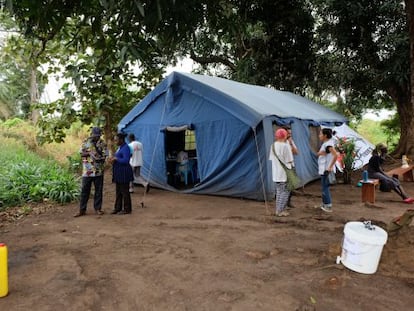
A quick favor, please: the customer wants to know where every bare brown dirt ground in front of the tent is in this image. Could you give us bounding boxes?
[0,172,414,311]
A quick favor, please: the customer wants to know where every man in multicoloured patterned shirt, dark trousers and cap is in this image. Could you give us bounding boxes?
[74,127,108,217]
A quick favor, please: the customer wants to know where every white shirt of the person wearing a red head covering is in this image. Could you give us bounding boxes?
[269,141,293,182]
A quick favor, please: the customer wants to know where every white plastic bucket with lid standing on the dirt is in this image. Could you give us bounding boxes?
[340,221,388,274]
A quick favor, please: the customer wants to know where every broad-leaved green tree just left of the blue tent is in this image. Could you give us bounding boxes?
[34,12,166,145]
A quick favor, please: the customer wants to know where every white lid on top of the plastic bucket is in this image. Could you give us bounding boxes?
[344,221,388,245]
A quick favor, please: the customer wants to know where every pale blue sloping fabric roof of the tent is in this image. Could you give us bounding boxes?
[118,72,347,130]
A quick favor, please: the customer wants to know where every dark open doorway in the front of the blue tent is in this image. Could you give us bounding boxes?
[165,126,199,189]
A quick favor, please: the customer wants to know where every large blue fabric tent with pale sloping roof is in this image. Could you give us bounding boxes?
[118,72,346,200]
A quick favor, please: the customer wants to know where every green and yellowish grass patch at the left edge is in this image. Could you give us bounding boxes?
[0,122,80,210]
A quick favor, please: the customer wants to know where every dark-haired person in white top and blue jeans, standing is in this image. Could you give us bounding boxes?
[317,128,338,213]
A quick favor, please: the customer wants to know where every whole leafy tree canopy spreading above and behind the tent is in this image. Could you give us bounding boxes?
[0,0,414,153]
